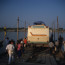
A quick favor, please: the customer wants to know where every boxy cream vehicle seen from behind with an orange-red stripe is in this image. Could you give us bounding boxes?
[27,24,49,47]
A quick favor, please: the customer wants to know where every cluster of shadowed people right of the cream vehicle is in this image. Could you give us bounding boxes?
[49,35,65,53]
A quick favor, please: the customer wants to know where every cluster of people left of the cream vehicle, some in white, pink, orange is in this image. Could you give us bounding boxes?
[6,38,27,64]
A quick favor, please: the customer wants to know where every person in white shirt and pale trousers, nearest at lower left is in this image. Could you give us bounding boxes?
[6,41,15,64]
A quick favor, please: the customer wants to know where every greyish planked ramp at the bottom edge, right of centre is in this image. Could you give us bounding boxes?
[36,54,57,65]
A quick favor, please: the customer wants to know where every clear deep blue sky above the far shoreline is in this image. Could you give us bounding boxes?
[0,0,65,28]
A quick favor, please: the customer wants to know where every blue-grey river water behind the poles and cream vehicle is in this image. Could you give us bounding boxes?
[0,32,65,41]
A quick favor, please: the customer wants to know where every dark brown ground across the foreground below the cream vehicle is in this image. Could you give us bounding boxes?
[0,47,65,65]
